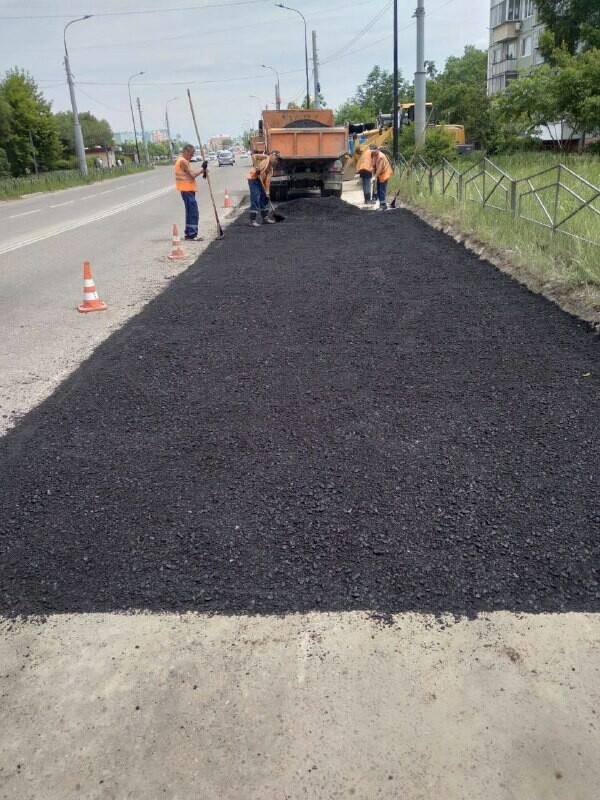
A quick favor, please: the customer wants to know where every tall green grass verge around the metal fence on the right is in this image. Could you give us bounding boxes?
[390,153,600,320]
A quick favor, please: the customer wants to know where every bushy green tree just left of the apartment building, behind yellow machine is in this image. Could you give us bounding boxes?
[427,45,491,143]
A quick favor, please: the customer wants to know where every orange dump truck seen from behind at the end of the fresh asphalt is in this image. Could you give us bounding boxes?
[252,108,348,201]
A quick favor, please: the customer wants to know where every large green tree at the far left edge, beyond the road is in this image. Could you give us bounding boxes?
[0,68,61,176]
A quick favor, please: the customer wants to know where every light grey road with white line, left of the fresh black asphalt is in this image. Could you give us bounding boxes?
[0,162,247,433]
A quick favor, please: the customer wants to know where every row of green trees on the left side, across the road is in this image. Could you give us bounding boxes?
[0,68,114,178]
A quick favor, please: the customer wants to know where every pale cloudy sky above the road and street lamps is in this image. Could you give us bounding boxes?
[0,0,489,142]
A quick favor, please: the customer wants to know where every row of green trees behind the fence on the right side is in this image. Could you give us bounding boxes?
[336,0,600,154]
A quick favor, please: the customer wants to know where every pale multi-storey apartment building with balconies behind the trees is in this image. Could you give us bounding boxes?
[487,0,544,94]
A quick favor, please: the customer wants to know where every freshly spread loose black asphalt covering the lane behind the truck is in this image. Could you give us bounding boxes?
[0,199,600,616]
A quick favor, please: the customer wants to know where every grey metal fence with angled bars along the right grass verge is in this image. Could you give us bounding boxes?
[397,155,600,247]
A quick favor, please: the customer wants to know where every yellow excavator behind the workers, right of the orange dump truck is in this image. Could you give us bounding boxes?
[344,103,473,179]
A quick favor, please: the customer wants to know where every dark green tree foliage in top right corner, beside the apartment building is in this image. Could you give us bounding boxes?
[535,0,600,56]
